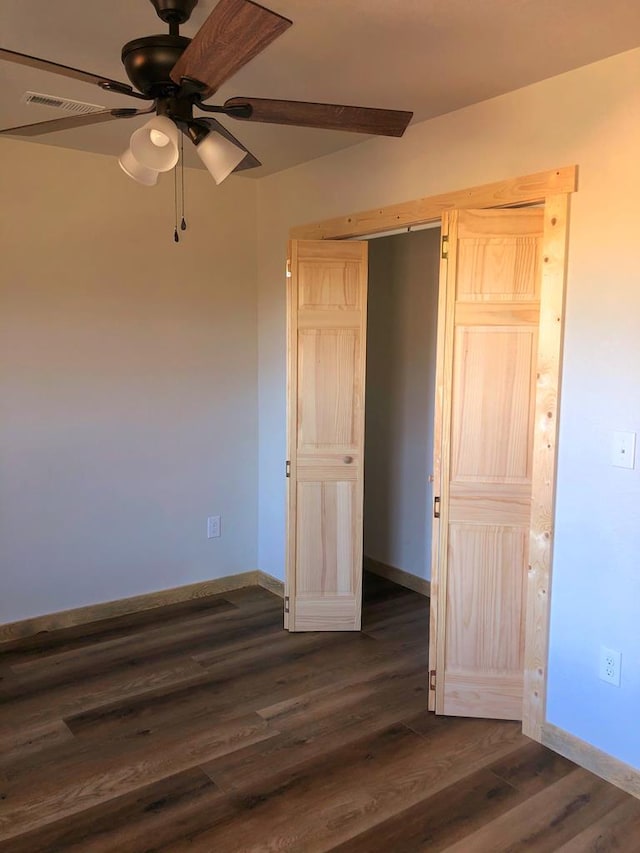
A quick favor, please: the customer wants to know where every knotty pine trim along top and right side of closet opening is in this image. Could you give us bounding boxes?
[289,166,578,741]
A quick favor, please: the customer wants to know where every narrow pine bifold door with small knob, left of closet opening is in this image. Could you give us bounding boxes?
[285,240,367,631]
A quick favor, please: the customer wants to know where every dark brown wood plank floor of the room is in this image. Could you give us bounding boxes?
[0,578,640,853]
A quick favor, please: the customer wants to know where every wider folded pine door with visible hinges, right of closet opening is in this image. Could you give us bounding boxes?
[430,208,543,719]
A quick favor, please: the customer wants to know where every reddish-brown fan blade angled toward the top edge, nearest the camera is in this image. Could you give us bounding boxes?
[171,0,292,98]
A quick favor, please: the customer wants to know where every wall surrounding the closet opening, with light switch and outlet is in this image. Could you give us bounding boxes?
[258,49,640,767]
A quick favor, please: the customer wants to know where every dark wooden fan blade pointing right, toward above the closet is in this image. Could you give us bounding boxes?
[224,98,413,136]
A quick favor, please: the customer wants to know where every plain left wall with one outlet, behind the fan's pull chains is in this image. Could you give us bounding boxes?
[0,139,257,622]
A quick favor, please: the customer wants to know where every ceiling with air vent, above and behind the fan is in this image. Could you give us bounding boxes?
[0,0,640,177]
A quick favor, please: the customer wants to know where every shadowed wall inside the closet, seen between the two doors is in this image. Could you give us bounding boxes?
[364,229,440,580]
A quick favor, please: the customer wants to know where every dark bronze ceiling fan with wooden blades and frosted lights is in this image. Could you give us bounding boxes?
[0,0,413,185]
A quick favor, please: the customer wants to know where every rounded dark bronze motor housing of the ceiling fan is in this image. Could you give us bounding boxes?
[122,34,191,97]
